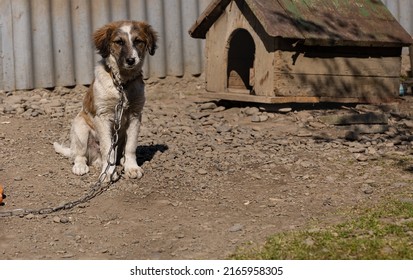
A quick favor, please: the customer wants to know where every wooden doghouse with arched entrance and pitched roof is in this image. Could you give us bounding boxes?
[189,0,412,103]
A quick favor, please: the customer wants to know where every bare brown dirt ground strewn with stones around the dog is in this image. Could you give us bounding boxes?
[0,77,413,259]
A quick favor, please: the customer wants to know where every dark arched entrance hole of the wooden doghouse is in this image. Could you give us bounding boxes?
[227,29,255,94]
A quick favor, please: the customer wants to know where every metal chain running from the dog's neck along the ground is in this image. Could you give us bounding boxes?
[0,83,127,218]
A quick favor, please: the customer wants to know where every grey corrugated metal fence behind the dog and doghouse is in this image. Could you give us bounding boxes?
[0,0,413,91]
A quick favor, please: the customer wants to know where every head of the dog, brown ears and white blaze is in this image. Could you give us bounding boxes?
[93,21,158,70]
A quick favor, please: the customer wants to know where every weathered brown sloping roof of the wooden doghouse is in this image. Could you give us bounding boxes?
[189,0,413,46]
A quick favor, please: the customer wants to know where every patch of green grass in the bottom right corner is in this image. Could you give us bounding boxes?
[230,200,413,260]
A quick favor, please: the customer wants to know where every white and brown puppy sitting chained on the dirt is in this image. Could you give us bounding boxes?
[54,21,157,181]
